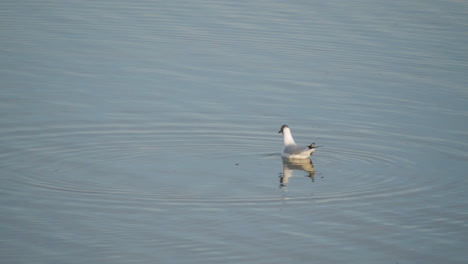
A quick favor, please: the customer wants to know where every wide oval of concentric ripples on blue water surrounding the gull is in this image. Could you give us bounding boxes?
[1,119,450,207]
